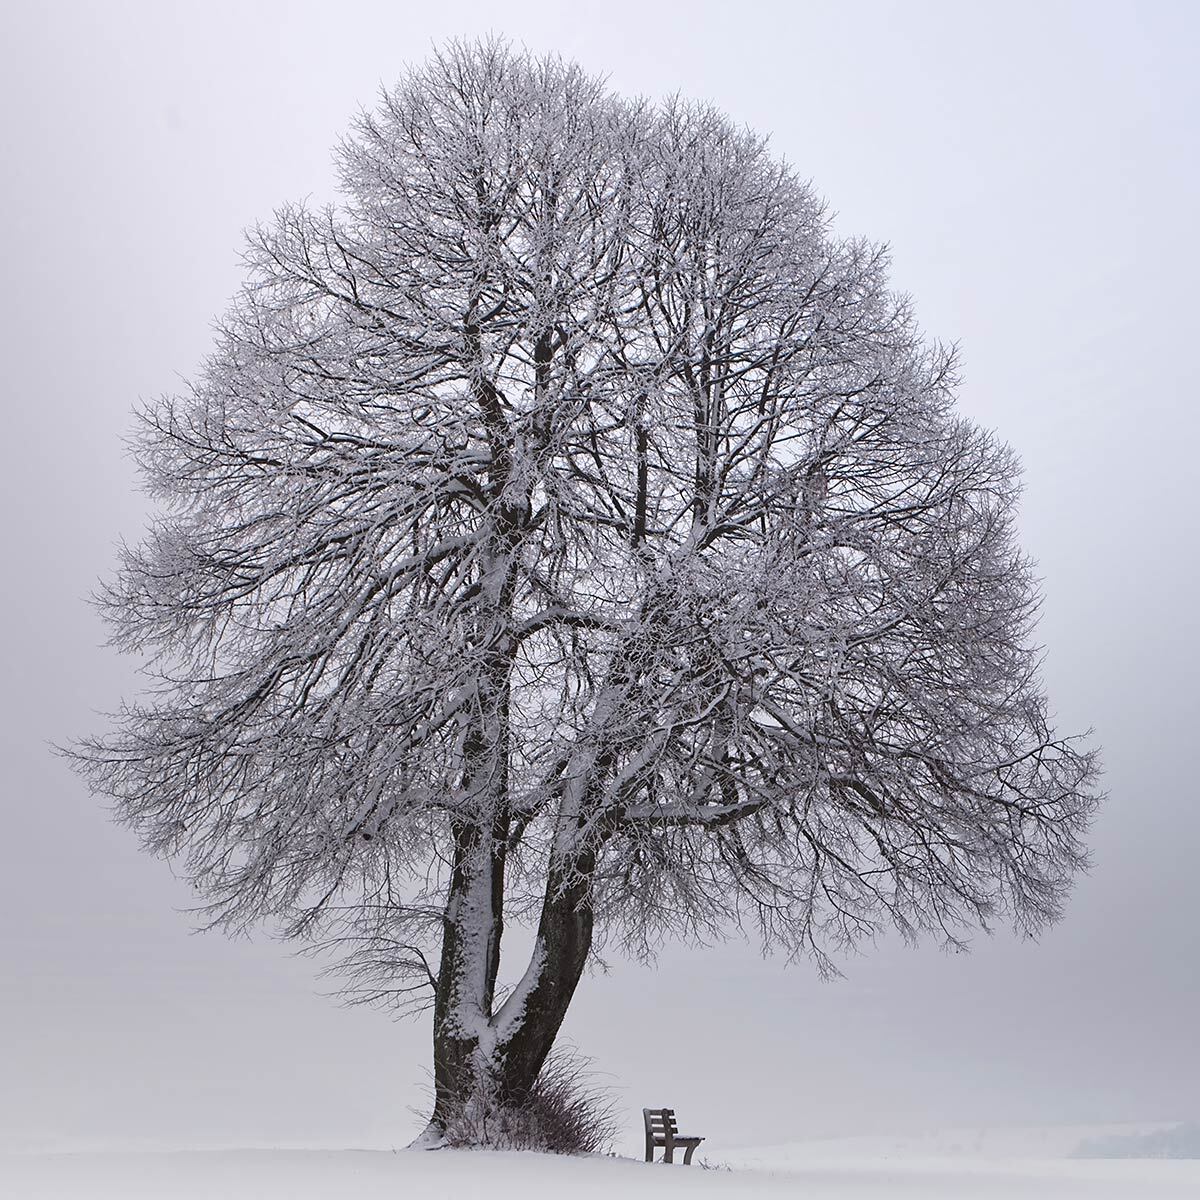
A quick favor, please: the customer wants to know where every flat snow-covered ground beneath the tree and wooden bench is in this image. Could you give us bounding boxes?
[0,1129,1200,1200]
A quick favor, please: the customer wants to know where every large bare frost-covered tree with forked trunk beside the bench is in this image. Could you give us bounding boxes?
[68,42,1096,1132]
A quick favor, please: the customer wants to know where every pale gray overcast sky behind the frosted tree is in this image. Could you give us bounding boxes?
[0,0,1200,1157]
